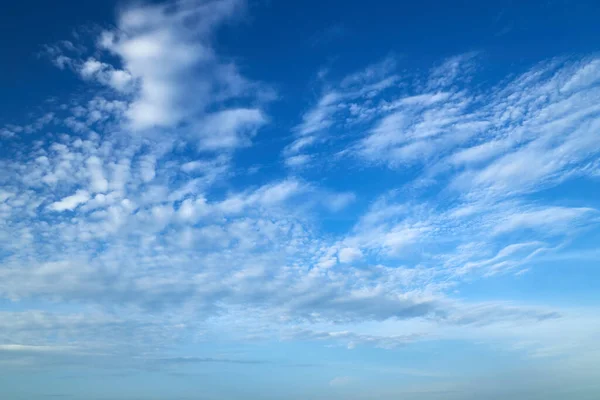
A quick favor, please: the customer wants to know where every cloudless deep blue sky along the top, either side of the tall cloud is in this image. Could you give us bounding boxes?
[0,0,600,119]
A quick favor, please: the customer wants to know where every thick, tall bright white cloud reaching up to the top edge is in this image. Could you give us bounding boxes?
[95,0,264,131]
